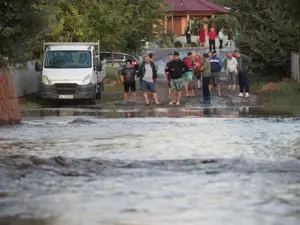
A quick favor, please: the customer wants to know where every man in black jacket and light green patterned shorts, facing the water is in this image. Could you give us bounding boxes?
[168,52,187,105]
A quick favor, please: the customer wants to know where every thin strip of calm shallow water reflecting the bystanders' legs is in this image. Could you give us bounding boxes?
[19,106,292,118]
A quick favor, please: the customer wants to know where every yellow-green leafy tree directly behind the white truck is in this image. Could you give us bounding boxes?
[48,0,166,51]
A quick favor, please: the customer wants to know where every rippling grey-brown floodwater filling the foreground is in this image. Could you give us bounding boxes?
[0,108,300,225]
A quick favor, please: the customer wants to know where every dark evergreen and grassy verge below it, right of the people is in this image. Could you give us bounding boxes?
[210,0,300,114]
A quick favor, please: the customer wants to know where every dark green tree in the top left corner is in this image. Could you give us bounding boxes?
[0,0,49,66]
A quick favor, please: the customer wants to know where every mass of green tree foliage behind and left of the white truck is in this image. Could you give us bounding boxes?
[0,0,166,67]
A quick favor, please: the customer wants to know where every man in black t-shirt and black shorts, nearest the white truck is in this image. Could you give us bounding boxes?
[121,59,136,104]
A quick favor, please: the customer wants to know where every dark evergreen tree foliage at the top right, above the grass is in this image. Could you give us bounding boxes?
[211,0,300,76]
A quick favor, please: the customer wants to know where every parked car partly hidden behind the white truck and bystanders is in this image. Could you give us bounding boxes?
[100,52,141,69]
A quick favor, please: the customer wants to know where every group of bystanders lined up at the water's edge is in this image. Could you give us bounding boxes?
[121,50,251,105]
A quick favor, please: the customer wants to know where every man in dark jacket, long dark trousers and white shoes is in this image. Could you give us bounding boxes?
[234,50,252,98]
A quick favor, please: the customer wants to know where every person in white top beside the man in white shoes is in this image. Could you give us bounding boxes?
[223,52,238,91]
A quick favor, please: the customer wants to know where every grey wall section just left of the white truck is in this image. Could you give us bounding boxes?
[12,61,42,97]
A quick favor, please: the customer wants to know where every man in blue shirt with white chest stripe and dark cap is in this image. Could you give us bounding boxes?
[209,51,223,96]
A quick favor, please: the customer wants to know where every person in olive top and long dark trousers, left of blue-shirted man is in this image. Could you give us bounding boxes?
[200,53,211,104]
